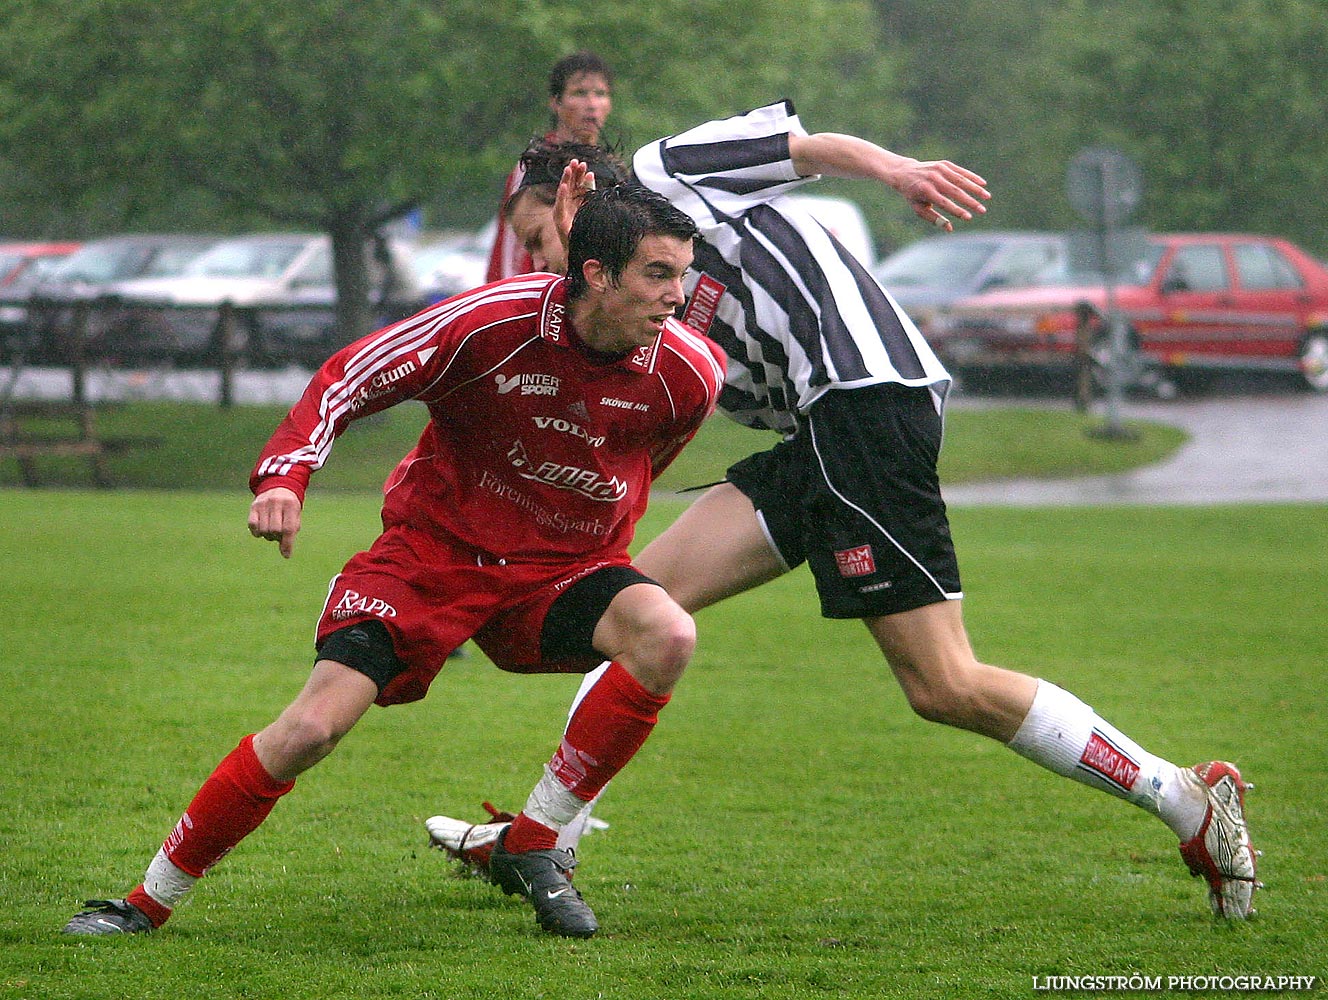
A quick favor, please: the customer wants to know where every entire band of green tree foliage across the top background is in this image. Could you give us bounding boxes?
[0,0,1328,333]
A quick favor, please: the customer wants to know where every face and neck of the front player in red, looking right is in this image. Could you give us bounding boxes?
[583,236,692,353]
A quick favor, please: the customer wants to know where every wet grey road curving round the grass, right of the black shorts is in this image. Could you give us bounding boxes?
[944,389,1328,506]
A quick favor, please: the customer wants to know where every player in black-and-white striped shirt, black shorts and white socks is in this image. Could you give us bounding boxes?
[428,102,1259,919]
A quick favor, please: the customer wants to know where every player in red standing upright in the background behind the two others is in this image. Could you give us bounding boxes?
[485,52,614,282]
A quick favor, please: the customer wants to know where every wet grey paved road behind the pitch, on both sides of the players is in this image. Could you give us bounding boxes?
[0,368,1328,506]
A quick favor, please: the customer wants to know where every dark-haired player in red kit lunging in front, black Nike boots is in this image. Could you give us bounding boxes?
[65,187,724,938]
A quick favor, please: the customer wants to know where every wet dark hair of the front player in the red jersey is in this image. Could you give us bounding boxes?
[567,183,697,299]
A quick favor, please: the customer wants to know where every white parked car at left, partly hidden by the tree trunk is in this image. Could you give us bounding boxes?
[108,232,418,363]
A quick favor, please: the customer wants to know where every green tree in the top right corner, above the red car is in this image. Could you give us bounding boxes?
[1003,0,1328,252]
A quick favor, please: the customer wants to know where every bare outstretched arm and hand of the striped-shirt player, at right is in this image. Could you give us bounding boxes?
[789,131,991,232]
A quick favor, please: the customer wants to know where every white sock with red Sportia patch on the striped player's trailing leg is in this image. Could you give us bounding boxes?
[1009,680,1207,841]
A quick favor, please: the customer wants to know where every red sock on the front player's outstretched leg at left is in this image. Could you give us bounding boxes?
[163,736,295,878]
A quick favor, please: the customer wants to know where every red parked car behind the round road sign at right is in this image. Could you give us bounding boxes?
[930,232,1328,392]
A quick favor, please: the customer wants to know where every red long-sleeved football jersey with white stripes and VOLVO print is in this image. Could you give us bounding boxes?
[250,275,724,562]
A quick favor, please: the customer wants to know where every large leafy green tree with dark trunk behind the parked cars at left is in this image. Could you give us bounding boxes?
[0,0,903,337]
